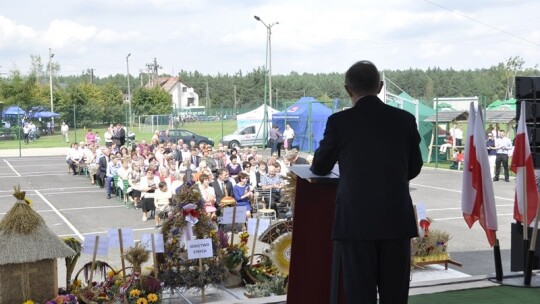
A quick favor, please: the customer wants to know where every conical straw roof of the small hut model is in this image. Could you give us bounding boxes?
[0,186,75,265]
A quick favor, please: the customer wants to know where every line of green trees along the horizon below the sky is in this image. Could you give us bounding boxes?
[0,55,539,126]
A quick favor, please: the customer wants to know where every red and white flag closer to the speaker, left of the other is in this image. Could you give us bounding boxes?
[462,104,498,247]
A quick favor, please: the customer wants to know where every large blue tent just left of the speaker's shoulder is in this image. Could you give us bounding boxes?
[272,97,332,152]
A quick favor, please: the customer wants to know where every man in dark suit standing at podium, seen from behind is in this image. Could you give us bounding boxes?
[311,61,422,304]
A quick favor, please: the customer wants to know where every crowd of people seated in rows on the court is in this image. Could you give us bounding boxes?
[66,139,308,227]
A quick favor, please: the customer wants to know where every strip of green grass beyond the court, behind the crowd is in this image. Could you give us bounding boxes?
[0,120,236,149]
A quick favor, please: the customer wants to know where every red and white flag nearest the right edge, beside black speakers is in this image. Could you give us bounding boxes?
[510,101,538,226]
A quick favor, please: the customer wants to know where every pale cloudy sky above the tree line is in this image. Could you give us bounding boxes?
[0,0,540,77]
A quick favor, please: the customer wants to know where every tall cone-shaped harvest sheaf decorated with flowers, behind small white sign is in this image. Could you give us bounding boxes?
[159,185,227,289]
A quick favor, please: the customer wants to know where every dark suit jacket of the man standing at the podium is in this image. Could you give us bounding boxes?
[311,96,423,240]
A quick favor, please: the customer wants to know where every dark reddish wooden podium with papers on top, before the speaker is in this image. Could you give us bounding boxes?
[287,165,339,304]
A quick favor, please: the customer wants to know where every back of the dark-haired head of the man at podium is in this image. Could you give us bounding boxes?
[345,60,381,92]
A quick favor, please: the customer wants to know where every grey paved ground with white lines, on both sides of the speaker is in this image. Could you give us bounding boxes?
[0,148,536,303]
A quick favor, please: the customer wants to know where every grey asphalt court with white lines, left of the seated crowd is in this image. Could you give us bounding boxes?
[0,156,157,239]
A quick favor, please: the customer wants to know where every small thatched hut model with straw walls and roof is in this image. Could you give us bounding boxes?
[0,187,75,304]
